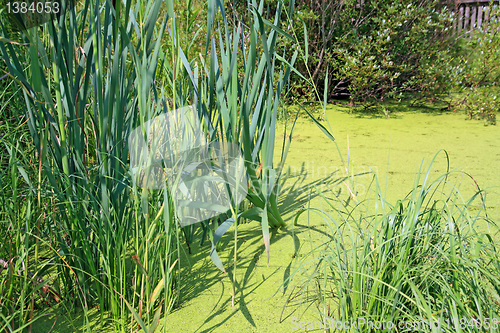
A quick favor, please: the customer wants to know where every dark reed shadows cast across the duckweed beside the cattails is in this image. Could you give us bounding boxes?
[170,164,374,332]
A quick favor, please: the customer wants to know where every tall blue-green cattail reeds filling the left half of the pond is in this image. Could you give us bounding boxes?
[0,0,324,331]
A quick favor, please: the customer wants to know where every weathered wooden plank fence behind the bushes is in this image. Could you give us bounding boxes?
[451,0,499,35]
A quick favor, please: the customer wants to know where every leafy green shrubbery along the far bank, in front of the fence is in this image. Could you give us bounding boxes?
[228,0,500,123]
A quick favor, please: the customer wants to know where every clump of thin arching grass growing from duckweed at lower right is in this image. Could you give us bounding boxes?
[292,152,500,332]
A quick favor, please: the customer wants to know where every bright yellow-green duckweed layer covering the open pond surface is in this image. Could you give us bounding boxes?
[33,106,500,332]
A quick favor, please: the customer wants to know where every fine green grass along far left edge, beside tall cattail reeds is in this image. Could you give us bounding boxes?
[0,19,53,332]
